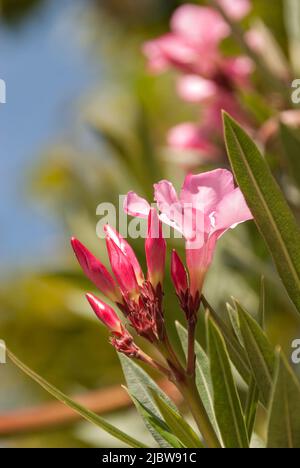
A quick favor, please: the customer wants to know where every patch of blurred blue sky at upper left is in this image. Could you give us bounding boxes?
[0,0,96,268]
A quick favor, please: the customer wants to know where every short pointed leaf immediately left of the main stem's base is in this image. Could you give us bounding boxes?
[151,391,204,448]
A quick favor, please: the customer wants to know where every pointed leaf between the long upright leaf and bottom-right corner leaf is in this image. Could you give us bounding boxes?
[235,302,275,406]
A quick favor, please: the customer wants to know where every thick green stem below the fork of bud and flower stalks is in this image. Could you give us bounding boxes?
[178,378,222,448]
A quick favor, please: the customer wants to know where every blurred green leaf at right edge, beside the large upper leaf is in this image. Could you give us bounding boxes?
[280,123,300,187]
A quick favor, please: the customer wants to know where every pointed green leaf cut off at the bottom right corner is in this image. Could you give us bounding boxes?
[268,353,300,448]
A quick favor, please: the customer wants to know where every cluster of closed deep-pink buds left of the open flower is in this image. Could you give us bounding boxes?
[71,209,166,348]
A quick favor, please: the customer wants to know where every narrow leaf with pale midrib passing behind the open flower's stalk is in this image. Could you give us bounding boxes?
[176,322,219,433]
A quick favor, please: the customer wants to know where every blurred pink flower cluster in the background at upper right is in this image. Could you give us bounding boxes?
[143,0,253,161]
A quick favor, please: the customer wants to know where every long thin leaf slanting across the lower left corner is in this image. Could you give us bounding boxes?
[7,350,147,448]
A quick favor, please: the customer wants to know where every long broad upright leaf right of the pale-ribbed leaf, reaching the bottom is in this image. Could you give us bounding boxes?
[207,318,249,448]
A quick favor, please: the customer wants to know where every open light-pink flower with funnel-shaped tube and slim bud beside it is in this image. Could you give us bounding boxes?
[124,169,252,309]
